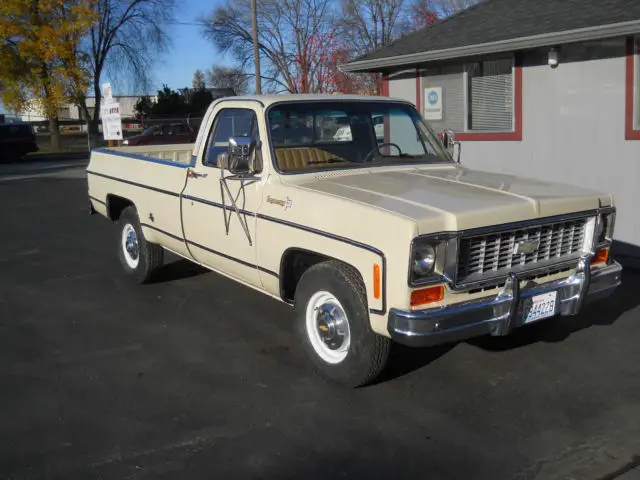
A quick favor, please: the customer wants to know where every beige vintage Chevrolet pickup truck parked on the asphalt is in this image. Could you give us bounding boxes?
[87,95,621,386]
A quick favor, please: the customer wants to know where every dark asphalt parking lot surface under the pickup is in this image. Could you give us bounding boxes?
[0,158,640,480]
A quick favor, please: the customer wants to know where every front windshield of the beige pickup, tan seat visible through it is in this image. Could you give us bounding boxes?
[267,101,453,172]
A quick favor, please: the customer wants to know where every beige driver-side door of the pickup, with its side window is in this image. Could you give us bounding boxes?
[182,102,266,286]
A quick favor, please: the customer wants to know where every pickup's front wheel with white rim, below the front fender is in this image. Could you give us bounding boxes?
[295,261,391,387]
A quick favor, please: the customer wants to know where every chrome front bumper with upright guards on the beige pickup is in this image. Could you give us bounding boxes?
[387,256,622,347]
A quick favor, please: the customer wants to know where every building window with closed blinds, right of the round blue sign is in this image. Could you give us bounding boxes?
[465,58,513,132]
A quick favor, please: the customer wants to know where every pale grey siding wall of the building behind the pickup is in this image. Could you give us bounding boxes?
[389,40,640,253]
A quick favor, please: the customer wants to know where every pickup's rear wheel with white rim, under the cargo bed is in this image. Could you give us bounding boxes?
[118,206,164,283]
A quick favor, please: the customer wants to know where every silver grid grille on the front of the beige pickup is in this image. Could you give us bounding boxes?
[456,218,587,285]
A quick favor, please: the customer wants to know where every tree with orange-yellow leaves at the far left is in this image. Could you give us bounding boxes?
[0,0,94,150]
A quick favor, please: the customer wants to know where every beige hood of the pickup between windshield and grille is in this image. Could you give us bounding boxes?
[296,165,612,234]
